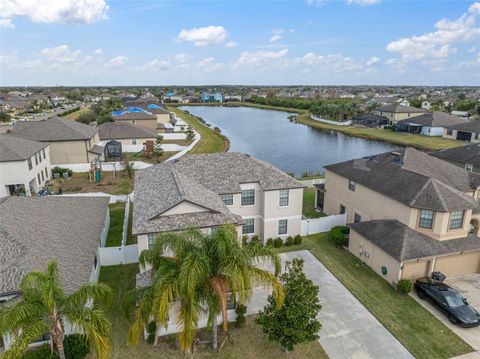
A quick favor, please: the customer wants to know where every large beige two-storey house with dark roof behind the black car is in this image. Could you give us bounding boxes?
[322,148,480,284]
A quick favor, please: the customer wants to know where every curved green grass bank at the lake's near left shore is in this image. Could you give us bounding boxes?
[167,106,229,154]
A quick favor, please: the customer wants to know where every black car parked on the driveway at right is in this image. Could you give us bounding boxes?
[415,278,480,328]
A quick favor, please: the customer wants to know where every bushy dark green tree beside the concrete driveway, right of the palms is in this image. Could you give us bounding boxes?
[257,259,321,351]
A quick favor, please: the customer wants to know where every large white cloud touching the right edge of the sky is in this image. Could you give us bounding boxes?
[387,2,480,62]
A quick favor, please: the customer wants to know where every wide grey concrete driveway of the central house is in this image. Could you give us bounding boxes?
[281,251,413,359]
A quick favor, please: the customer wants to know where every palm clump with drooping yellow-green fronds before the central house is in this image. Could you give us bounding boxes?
[129,225,284,353]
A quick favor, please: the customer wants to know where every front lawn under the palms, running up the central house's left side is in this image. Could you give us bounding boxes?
[100,264,327,359]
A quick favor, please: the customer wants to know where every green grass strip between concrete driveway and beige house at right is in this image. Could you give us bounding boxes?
[280,233,473,359]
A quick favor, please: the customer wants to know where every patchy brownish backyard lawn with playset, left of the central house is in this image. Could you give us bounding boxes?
[53,171,133,194]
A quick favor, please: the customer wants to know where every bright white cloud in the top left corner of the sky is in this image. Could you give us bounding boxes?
[0,0,109,24]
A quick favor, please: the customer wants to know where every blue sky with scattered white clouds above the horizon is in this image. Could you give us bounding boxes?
[0,0,480,86]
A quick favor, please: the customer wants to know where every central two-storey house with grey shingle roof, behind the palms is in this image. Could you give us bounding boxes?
[133,153,303,252]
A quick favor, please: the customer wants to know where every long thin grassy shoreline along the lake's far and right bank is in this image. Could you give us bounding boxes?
[172,102,464,151]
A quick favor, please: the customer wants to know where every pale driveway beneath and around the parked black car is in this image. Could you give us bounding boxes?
[411,273,480,359]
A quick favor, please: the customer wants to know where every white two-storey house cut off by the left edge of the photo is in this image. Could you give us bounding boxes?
[0,134,51,198]
